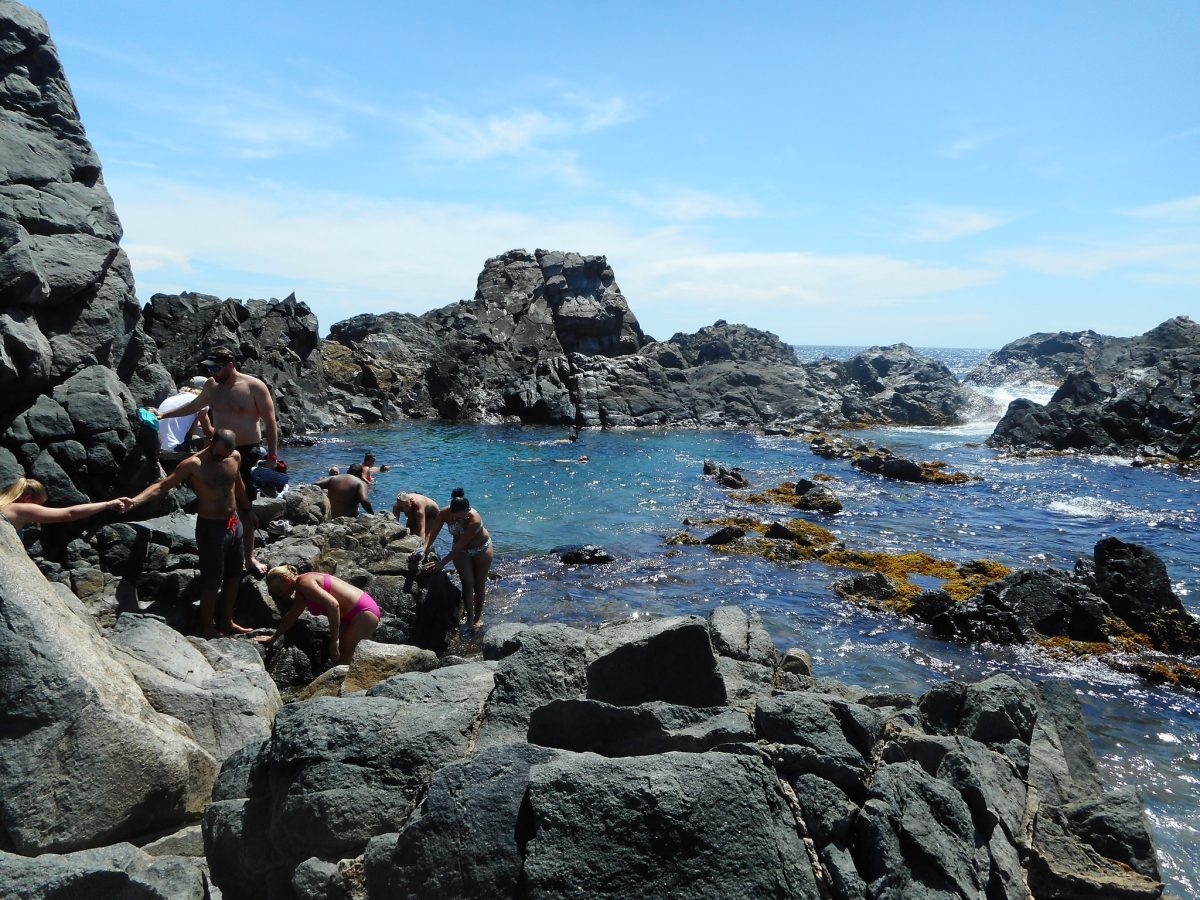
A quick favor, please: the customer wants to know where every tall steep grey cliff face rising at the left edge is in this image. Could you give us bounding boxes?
[0,2,173,503]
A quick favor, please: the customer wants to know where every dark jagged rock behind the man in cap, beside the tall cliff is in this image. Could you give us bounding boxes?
[143,292,336,434]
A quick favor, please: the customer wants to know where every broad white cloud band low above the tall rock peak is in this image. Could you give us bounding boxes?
[109,170,995,335]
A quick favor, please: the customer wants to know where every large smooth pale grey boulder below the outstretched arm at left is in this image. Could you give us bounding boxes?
[0,522,217,853]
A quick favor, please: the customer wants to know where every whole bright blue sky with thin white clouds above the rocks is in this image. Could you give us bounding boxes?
[35,0,1200,347]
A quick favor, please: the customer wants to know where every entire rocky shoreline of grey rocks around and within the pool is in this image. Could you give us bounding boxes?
[0,0,1194,900]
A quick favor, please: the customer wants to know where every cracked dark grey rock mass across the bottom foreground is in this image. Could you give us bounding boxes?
[204,607,1162,900]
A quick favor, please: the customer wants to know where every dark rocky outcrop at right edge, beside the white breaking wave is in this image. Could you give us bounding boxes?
[967,316,1200,460]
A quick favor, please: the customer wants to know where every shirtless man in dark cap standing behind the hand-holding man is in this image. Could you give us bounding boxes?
[158,347,280,575]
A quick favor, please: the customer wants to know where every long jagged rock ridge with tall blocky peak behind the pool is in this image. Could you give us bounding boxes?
[323,250,977,426]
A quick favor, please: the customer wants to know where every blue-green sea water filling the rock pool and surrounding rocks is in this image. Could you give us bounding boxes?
[278,347,1200,898]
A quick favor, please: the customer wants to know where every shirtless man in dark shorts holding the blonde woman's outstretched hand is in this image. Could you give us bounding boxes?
[130,428,250,638]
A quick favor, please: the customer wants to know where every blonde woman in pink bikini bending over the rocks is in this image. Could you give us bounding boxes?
[254,565,382,666]
